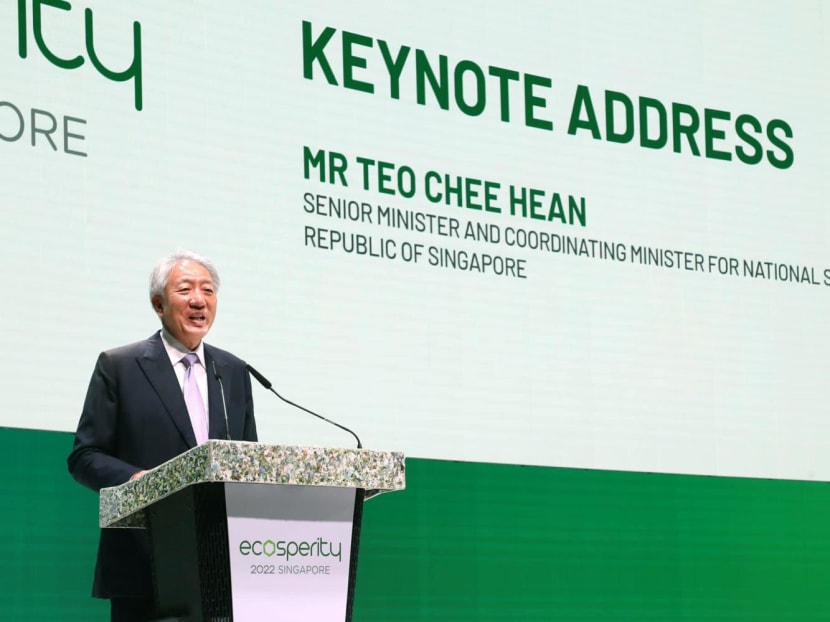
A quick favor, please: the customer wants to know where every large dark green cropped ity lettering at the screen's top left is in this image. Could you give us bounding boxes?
[17,0,144,110]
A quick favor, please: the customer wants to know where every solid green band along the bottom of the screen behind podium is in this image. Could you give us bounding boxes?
[0,428,830,622]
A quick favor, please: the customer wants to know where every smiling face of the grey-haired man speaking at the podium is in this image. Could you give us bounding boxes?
[152,260,216,350]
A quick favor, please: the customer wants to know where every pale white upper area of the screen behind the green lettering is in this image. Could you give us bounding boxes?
[0,0,830,479]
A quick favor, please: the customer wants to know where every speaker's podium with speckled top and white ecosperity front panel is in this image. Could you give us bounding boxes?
[99,440,405,622]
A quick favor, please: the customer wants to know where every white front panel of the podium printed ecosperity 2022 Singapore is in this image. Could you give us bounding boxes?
[225,483,357,622]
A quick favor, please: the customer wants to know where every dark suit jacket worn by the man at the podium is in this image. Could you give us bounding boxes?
[67,333,257,598]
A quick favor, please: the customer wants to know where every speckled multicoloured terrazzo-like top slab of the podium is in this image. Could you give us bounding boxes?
[99,440,406,528]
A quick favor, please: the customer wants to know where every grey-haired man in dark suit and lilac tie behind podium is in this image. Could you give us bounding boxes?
[67,251,257,622]
